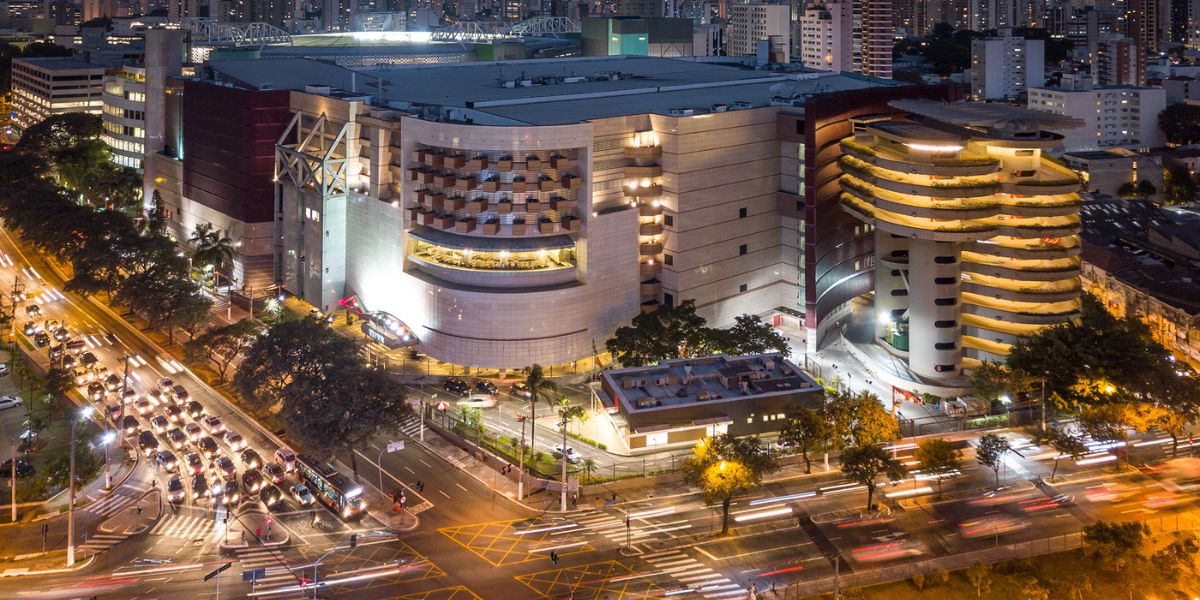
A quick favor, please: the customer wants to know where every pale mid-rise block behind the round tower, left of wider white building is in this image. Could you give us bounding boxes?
[971,29,1045,101]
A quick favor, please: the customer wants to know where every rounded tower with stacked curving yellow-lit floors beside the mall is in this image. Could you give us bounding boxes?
[839,101,1080,383]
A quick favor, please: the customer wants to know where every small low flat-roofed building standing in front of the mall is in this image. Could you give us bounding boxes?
[600,353,824,452]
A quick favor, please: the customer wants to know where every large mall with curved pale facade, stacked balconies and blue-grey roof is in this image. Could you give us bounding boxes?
[260,56,953,368]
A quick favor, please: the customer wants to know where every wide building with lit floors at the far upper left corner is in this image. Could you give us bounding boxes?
[12,58,104,128]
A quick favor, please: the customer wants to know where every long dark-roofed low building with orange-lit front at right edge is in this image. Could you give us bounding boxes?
[1082,198,1200,368]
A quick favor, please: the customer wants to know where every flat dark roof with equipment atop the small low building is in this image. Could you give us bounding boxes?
[604,353,820,413]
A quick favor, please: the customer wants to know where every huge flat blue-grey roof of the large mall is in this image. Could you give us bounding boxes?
[212,56,907,125]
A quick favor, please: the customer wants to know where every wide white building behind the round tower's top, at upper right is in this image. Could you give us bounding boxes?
[1028,85,1166,151]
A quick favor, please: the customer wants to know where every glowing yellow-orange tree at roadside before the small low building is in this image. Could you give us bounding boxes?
[683,433,779,535]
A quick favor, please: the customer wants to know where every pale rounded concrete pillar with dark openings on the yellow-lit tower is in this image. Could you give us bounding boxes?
[908,240,962,379]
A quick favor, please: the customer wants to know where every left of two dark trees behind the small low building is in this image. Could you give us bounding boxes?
[605,300,713,367]
